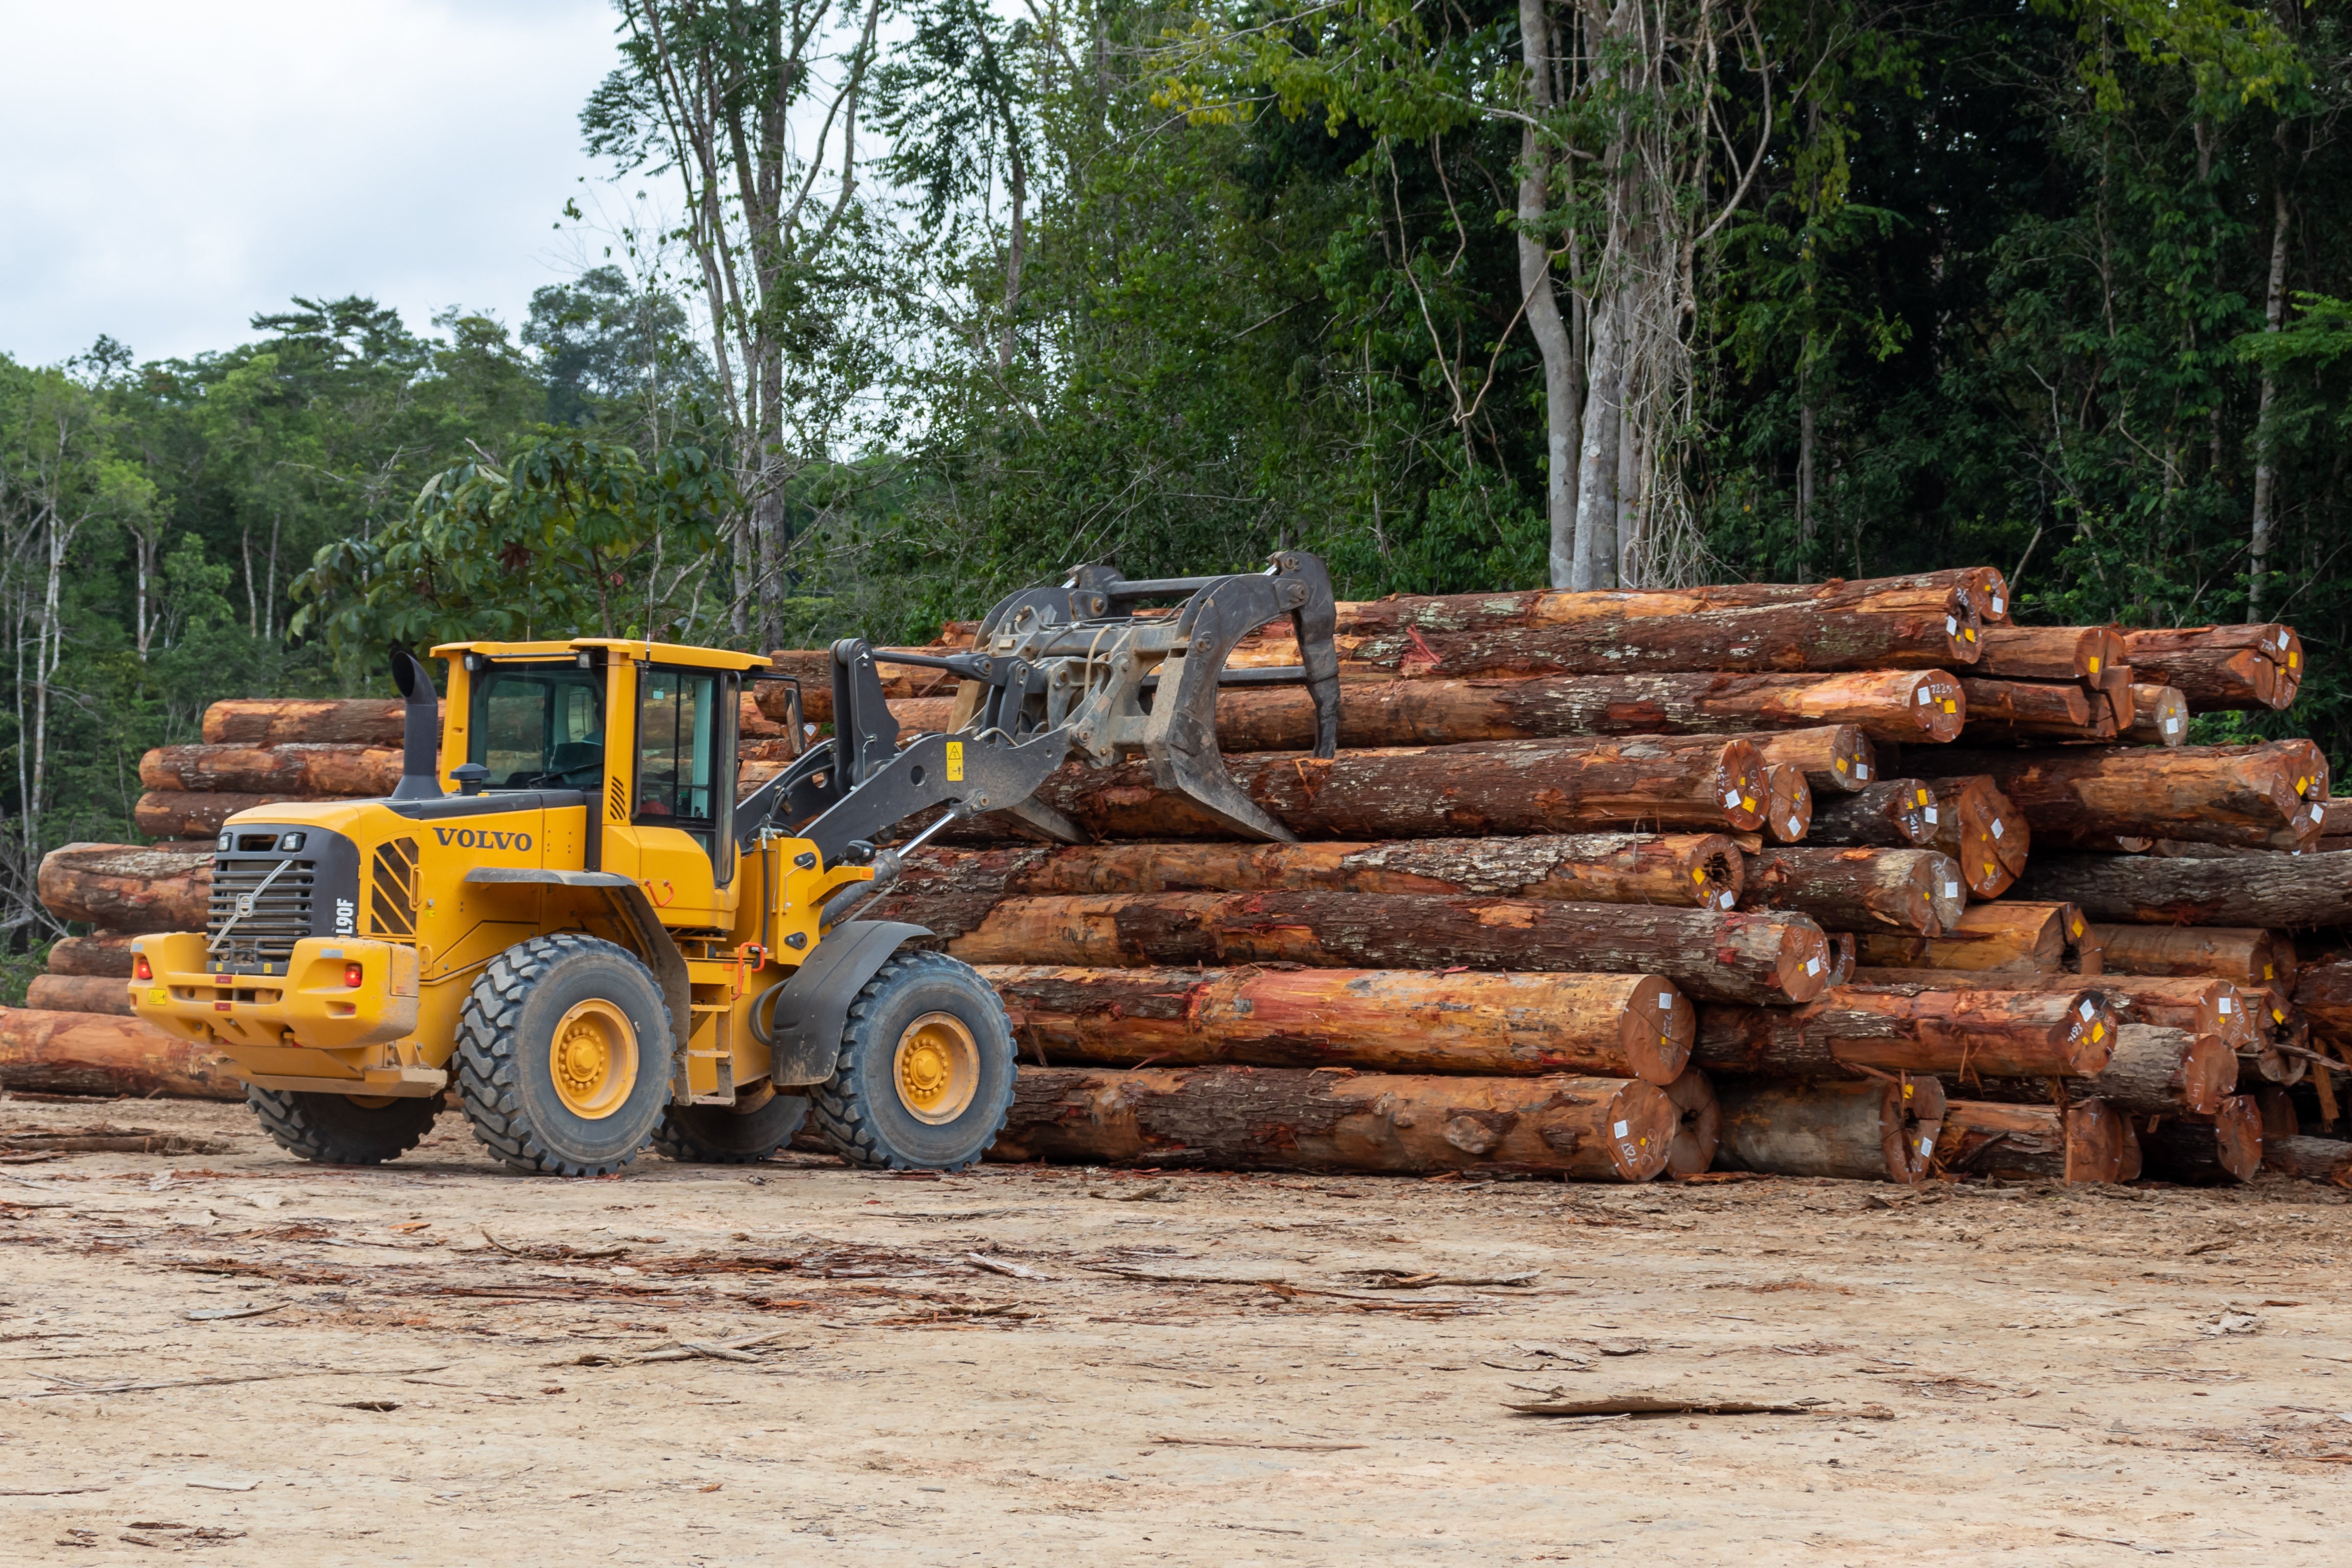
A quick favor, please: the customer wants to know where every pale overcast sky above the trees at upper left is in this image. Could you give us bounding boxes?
[0,0,616,365]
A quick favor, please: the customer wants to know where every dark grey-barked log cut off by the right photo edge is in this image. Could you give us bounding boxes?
[2015,851,2352,929]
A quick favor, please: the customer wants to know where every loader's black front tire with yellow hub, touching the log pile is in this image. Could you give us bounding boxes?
[809,952,1014,1171]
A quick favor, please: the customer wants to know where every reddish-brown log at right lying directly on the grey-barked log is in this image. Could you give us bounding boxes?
[1940,740,2329,849]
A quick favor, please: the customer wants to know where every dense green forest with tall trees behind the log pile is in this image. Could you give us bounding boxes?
[0,0,2352,952]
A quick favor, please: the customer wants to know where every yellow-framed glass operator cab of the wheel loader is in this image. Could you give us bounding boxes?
[433,637,767,929]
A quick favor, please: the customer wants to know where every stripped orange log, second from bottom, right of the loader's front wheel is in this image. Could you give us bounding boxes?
[981,964,1698,1086]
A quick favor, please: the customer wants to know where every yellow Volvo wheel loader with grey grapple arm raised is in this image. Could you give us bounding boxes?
[129,552,1338,1175]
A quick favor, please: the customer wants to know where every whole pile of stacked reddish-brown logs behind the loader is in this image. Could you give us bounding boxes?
[18,569,2352,1185]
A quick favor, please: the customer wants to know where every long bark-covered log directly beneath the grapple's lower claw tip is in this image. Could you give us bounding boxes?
[896,832,1745,926]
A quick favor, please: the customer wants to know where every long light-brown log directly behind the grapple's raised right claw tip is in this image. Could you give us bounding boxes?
[1176,670,1964,752]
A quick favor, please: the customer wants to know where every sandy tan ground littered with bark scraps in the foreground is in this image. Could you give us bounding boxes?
[0,1100,2352,1568]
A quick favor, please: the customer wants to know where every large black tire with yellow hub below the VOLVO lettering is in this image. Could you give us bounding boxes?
[457,931,670,1175]
